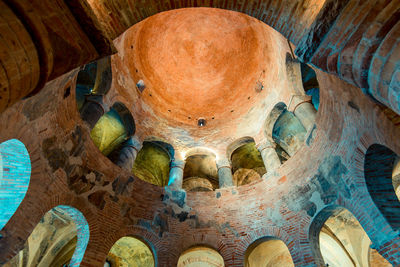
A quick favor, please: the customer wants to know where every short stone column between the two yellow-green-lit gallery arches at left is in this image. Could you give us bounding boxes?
[117,136,142,172]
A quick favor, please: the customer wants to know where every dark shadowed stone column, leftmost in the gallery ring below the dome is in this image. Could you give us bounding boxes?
[80,95,106,129]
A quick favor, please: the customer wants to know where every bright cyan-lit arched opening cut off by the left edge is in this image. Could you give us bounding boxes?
[0,139,31,230]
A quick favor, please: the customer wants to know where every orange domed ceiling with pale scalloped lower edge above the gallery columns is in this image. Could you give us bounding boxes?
[107,8,294,157]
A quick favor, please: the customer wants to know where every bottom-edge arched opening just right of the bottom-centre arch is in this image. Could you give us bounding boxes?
[244,237,294,267]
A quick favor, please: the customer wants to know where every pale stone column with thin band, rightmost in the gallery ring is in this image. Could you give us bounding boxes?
[288,95,317,132]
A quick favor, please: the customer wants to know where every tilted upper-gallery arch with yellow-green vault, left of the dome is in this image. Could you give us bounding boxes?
[90,102,135,156]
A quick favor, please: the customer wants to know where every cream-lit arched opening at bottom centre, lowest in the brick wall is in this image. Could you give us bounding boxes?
[178,246,225,267]
